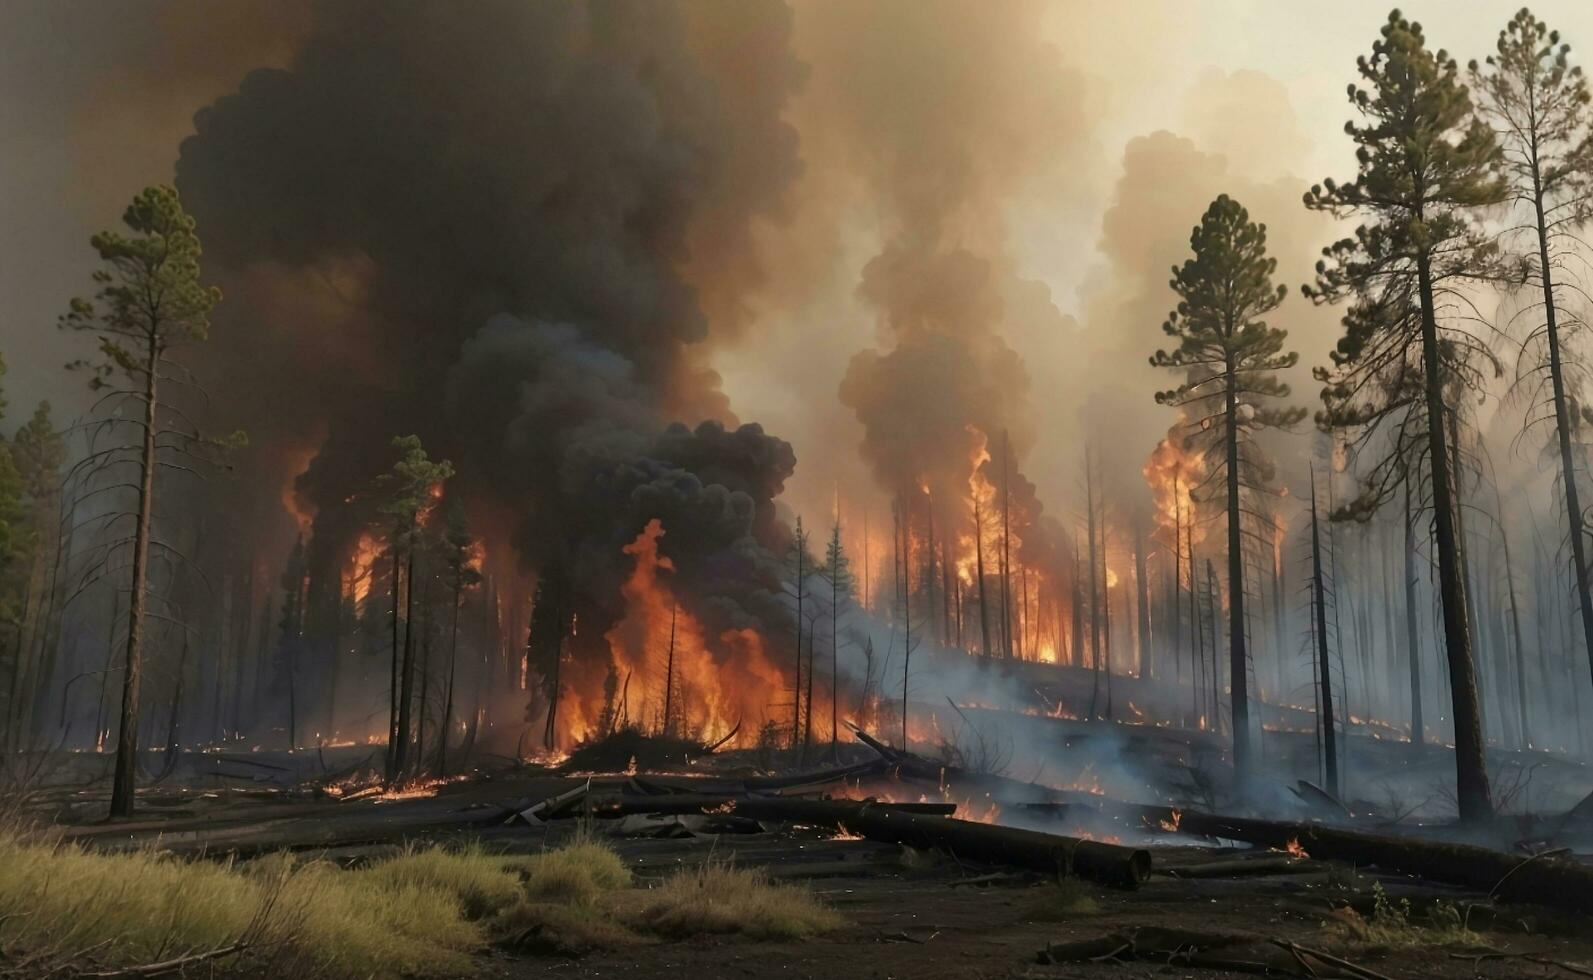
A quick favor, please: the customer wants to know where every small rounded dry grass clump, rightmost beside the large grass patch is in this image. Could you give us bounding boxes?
[636,862,844,939]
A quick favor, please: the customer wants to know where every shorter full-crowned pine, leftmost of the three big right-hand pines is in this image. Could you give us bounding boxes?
[1150,194,1305,787]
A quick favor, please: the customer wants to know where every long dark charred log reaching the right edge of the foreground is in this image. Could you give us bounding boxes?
[1110,805,1593,913]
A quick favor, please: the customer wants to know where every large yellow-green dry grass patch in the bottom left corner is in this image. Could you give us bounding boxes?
[0,827,519,977]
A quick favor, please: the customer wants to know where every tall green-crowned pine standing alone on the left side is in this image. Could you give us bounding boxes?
[61,186,241,816]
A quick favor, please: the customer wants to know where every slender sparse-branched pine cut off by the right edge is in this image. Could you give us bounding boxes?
[1470,8,1593,697]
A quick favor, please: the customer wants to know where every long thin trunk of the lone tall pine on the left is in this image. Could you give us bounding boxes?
[110,331,161,817]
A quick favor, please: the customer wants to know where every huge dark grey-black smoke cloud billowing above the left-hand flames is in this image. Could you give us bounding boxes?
[177,0,801,720]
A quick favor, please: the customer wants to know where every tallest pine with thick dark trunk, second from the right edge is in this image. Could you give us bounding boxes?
[1305,11,1504,822]
